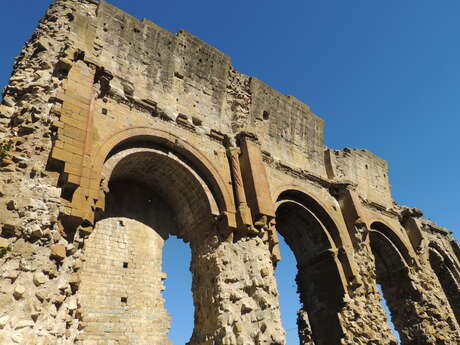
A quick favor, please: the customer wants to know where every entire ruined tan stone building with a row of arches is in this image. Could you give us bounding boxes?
[0,0,460,345]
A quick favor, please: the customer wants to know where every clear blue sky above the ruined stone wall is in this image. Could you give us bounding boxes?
[0,0,460,344]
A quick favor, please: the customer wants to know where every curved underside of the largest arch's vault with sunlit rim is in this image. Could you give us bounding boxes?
[102,148,218,239]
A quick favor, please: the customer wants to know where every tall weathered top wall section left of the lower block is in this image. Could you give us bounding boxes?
[87,2,324,175]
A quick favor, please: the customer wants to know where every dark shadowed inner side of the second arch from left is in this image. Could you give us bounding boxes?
[276,194,346,345]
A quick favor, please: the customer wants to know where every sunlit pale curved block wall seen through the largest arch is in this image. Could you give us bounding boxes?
[80,217,170,344]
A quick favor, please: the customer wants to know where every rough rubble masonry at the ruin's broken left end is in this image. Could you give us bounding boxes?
[0,0,97,345]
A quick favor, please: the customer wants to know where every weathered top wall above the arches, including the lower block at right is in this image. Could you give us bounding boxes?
[1,1,392,207]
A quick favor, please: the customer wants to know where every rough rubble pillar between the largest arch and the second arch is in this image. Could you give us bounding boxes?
[189,228,285,345]
